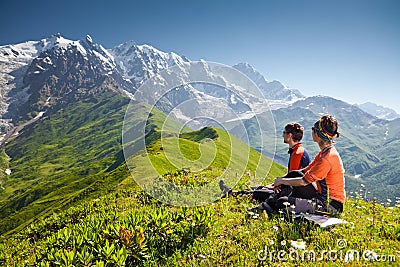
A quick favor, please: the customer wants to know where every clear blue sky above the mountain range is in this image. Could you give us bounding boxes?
[0,0,400,113]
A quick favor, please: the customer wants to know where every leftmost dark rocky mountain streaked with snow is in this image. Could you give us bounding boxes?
[0,34,132,129]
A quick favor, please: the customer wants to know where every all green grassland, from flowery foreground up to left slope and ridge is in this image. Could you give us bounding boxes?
[0,95,400,266]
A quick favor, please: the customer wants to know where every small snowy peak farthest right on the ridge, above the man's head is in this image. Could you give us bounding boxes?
[233,63,305,101]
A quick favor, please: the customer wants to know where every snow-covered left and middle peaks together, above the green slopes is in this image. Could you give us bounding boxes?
[0,34,287,132]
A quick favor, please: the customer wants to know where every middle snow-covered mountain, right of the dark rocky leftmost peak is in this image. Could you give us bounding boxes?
[110,42,276,128]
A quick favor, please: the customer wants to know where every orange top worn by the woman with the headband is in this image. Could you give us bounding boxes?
[302,146,346,203]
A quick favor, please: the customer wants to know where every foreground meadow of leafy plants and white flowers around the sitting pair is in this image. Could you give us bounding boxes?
[0,173,400,266]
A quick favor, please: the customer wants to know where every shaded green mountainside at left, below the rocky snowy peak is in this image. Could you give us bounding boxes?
[0,93,128,236]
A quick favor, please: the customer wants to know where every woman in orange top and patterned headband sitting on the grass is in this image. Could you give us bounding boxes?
[255,115,346,214]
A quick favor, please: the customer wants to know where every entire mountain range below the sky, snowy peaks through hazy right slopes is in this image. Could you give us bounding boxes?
[0,35,400,201]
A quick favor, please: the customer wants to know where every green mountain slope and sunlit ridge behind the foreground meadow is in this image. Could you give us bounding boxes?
[0,89,284,234]
